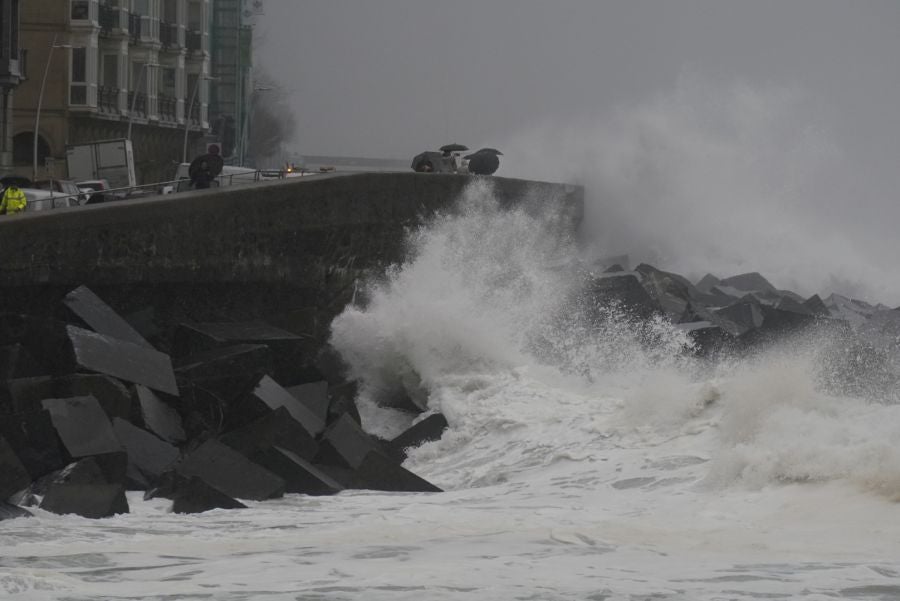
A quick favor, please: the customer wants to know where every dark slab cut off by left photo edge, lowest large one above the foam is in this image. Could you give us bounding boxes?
[0,409,66,480]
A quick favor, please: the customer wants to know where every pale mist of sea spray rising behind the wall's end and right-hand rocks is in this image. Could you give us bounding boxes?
[500,75,900,306]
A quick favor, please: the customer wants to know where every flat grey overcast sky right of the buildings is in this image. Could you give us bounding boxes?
[255,0,900,302]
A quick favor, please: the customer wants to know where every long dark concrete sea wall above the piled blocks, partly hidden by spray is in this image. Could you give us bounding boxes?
[0,173,583,354]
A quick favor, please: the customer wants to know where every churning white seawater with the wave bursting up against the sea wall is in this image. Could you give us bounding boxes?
[0,181,900,601]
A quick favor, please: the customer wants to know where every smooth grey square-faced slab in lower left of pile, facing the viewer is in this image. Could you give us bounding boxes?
[42,396,122,458]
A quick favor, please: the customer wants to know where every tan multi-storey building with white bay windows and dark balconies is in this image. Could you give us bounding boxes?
[13,0,212,183]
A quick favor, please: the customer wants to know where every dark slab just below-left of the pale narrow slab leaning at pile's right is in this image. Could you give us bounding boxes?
[219,407,319,461]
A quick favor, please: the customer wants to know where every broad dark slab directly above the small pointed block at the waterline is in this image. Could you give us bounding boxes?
[176,440,285,501]
